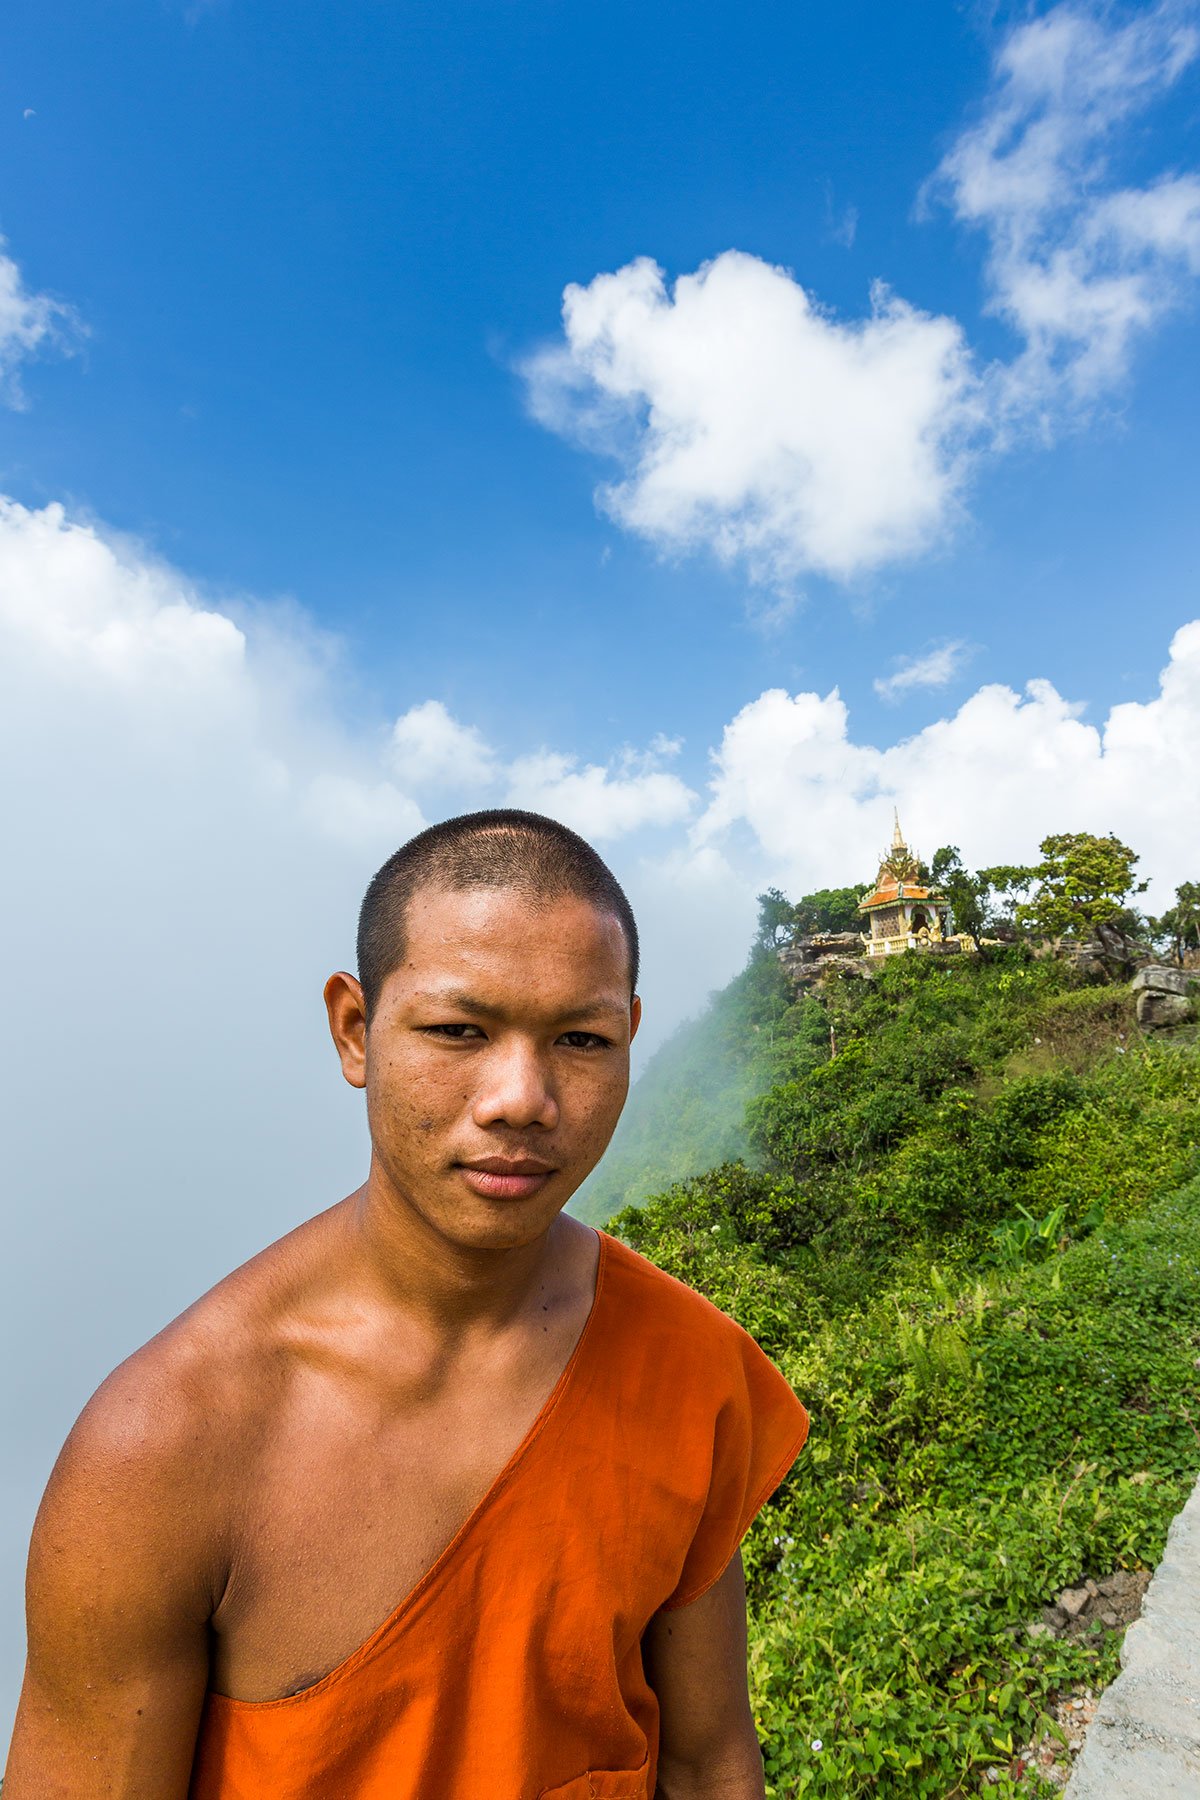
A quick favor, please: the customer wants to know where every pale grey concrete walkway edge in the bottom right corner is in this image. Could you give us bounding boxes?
[1067,1483,1200,1800]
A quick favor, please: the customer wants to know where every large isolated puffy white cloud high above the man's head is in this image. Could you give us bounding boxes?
[525,250,975,585]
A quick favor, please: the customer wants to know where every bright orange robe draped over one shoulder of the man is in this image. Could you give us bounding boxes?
[191,1233,808,1800]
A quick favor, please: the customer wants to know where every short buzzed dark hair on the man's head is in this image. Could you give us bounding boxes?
[358,806,639,1021]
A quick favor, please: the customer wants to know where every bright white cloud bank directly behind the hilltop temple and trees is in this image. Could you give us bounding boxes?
[694,619,1200,905]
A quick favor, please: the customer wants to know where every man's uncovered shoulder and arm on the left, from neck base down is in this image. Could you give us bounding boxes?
[5,1220,347,1800]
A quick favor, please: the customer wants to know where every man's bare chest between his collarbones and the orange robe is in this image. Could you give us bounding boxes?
[212,1357,565,1701]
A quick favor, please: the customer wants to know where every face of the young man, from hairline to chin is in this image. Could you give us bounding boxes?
[347,887,639,1249]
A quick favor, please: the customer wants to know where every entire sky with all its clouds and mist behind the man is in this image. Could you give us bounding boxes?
[0,0,1200,1742]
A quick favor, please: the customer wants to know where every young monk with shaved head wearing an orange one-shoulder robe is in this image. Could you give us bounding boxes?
[4,812,806,1800]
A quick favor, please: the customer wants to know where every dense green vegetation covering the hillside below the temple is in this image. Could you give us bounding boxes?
[613,945,1200,1800]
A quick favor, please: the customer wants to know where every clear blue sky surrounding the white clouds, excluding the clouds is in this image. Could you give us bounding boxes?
[0,0,1196,748]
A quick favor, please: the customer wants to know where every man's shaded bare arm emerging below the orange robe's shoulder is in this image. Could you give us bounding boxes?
[644,1553,763,1800]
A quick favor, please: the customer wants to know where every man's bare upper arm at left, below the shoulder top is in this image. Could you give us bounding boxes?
[4,1370,223,1800]
